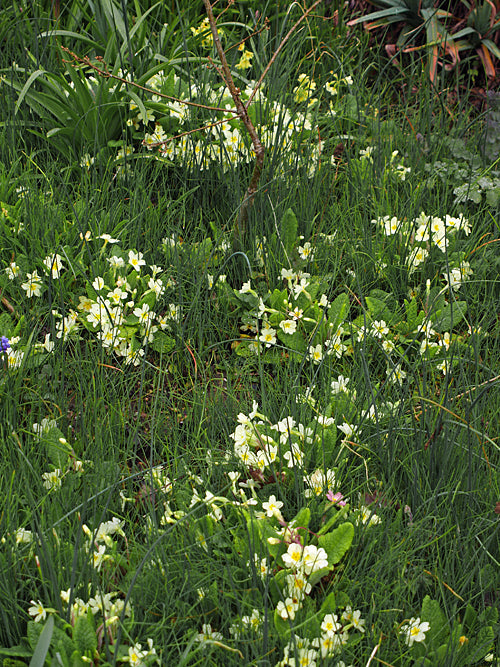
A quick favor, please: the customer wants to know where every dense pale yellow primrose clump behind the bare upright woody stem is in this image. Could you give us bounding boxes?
[124,70,319,177]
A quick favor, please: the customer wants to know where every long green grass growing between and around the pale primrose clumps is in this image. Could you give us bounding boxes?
[0,3,500,667]
